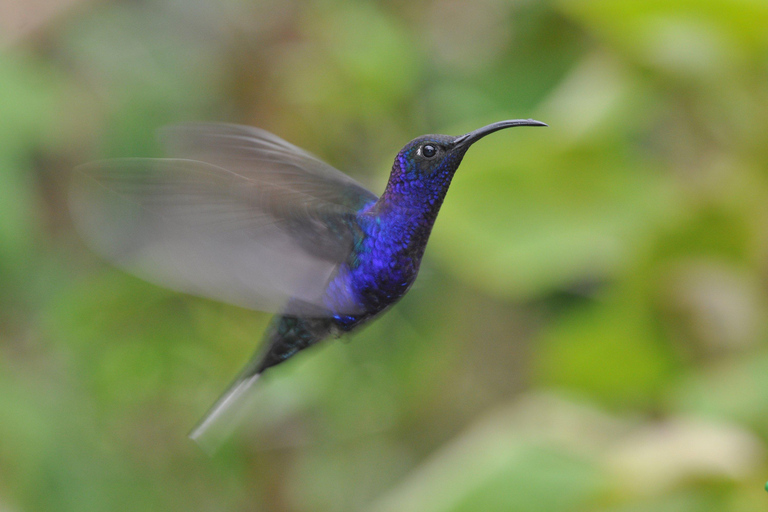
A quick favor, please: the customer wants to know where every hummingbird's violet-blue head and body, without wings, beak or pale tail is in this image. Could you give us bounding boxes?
[255,135,466,373]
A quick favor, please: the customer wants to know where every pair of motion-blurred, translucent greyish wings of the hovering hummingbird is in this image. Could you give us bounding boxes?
[72,125,376,314]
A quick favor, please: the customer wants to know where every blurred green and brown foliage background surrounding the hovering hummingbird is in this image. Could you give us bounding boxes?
[0,0,768,512]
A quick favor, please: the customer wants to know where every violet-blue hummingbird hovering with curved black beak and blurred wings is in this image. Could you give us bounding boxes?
[70,119,547,447]
